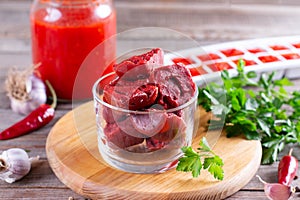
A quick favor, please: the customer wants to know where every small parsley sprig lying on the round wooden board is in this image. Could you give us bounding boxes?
[176,137,224,180]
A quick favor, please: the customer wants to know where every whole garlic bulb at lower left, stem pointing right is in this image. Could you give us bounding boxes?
[0,148,39,183]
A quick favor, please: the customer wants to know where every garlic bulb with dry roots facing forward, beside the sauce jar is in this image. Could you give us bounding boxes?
[5,66,47,115]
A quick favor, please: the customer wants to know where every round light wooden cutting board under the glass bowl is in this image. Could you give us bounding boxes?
[46,102,261,200]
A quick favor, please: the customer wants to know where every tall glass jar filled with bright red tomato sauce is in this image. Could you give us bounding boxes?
[30,0,116,100]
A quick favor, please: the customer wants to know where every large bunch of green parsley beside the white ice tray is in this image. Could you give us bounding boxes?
[198,60,300,164]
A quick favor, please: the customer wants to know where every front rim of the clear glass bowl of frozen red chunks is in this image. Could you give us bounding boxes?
[92,72,198,114]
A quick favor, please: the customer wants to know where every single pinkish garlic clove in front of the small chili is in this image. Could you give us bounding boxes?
[257,175,295,200]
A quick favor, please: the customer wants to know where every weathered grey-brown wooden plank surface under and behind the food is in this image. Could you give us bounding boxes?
[0,0,300,200]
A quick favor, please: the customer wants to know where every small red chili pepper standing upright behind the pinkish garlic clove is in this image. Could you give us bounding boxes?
[278,149,298,186]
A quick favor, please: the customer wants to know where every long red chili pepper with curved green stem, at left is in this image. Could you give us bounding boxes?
[0,81,56,140]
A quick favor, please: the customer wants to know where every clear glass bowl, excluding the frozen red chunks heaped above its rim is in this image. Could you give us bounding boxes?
[93,73,198,174]
